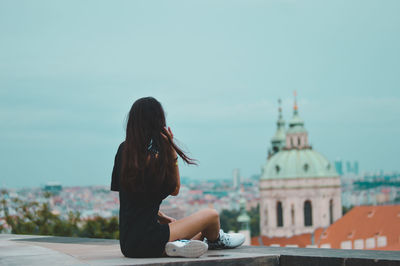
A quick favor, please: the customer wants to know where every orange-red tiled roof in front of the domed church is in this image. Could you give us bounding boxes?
[251,205,400,250]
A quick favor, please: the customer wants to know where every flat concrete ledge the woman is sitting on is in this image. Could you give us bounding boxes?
[0,234,400,266]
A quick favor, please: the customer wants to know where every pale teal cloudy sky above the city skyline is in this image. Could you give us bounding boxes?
[0,0,400,187]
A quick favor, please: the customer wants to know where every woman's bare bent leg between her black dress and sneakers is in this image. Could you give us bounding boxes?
[169,209,220,241]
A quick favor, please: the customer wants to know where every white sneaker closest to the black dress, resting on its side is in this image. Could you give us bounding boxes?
[165,240,208,258]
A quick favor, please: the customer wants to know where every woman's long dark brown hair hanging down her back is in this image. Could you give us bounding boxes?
[121,97,196,194]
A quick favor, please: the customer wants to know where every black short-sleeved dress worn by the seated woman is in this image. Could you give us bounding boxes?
[111,142,169,258]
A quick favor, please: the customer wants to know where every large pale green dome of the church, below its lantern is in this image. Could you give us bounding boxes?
[261,149,338,179]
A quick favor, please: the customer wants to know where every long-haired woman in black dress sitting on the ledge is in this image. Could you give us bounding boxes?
[111,97,244,257]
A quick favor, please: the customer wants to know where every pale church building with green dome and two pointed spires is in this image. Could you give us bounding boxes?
[260,98,342,237]
